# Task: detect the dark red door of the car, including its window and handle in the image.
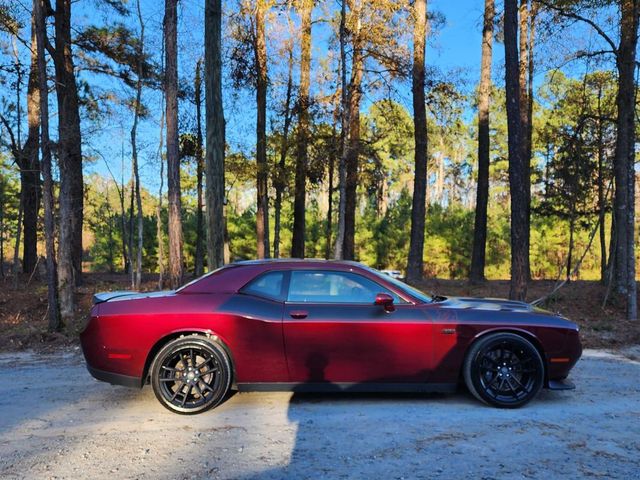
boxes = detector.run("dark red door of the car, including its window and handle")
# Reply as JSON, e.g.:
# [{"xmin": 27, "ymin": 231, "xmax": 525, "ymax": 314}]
[{"xmin": 283, "ymin": 270, "xmax": 432, "ymax": 383}]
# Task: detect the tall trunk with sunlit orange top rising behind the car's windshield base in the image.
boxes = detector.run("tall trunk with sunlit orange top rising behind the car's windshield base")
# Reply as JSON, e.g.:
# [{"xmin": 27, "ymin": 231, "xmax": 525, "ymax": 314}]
[{"xmin": 407, "ymin": 0, "xmax": 427, "ymax": 282}]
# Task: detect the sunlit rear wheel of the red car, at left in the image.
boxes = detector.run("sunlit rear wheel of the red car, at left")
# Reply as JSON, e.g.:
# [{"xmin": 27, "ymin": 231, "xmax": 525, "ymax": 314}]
[{"xmin": 151, "ymin": 335, "xmax": 232, "ymax": 415}]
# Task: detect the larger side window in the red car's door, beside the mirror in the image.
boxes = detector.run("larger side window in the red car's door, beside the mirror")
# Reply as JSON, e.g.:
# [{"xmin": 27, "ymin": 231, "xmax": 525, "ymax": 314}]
[{"xmin": 287, "ymin": 271, "xmax": 405, "ymax": 304}]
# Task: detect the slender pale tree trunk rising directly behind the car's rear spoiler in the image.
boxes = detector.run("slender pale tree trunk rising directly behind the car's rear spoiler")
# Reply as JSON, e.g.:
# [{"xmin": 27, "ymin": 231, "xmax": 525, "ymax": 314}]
[{"xmin": 131, "ymin": 0, "xmax": 144, "ymax": 290}]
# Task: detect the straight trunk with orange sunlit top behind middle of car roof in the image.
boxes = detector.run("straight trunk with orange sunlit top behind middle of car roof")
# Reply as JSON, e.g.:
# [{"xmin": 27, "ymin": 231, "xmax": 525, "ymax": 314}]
[{"xmin": 291, "ymin": 0, "xmax": 313, "ymax": 258}]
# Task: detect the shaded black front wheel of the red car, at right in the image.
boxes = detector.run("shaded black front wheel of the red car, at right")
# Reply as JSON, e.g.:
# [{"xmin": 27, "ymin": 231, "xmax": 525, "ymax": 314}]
[{"xmin": 463, "ymin": 333, "xmax": 544, "ymax": 408}]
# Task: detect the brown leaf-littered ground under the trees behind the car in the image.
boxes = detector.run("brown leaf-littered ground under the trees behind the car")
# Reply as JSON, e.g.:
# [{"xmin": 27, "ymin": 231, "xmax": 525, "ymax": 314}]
[{"xmin": 0, "ymin": 273, "xmax": 640, "ymax": 352}]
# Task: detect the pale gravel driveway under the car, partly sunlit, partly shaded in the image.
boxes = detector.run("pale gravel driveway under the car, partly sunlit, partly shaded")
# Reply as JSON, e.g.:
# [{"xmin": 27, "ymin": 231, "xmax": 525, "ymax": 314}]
[{"xmin": 0, "ymin": 350, "xmax": 640, "ymax": 480}]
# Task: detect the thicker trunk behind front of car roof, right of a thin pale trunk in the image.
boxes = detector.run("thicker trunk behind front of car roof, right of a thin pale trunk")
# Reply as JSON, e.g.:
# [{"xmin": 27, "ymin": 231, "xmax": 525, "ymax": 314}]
[{"xmin": 342, "ymin": 0, "xmax": 364, "ymax": 260}]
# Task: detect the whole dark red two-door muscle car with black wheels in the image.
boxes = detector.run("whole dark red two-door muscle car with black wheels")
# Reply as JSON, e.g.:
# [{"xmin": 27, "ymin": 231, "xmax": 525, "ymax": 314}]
[{"xmin": 81, "ymin": 260, "xmax": 582, "ymax": 413}]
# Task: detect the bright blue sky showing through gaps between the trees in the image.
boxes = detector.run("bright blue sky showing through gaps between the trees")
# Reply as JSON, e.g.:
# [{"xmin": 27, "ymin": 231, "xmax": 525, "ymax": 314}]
[{"xmin": 74, "ymin": 0, "xmax": 604, "ymax": 193}]
